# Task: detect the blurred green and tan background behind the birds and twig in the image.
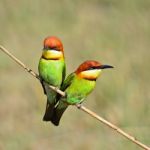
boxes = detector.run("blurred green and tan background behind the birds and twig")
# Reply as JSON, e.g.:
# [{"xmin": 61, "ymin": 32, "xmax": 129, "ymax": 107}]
[{"xmin": 0, "ymin": 0, "xmax": 150, "ymax": 150}]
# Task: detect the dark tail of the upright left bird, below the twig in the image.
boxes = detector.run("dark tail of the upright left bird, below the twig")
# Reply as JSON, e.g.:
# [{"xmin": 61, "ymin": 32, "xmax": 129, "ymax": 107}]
[{"xmin": 43, "ymin": 100, "xmax": 55, "ymax": 121}]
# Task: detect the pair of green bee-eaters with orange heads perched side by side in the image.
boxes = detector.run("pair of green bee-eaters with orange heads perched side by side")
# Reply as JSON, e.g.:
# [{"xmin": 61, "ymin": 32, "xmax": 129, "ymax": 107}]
[{"xmin": 38, "ymin": 36, "xmax": 113, "ymax": 126}]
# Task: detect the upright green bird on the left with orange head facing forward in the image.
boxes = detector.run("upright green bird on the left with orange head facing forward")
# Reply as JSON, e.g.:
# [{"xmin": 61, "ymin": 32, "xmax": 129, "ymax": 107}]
[{"xmin": 38, "ymin": 36, "xmax": 66, "ymax": 121}]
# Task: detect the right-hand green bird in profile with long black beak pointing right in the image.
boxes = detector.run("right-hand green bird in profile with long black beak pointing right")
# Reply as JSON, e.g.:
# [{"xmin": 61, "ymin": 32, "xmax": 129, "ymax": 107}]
[{"xmin": 51, "ymin": 60, "xmax": 113, "ymax": 126}]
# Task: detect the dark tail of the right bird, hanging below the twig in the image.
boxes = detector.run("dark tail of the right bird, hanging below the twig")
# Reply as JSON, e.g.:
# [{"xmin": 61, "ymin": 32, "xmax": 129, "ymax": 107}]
[{"xmin": 51, "ymin": 100, "xmax": 68, "ymax": 126}]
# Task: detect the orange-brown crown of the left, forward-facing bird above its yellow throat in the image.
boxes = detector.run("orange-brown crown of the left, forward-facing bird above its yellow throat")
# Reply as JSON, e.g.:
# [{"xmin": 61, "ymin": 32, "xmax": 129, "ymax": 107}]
[{"xmin": 44, "ymin": 36, "xmax": 63, "ymax": 52}]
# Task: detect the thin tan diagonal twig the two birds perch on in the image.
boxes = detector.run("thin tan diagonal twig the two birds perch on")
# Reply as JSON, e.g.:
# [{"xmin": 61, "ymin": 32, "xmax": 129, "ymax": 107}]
[{"xmin": 0, "ymin": 45, "xmax": 150, "ymax": 150}]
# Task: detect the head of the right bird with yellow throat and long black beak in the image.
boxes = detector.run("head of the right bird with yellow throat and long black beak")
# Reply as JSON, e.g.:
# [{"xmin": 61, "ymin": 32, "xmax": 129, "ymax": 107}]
[{"xmin": 75, "ymin": 60, "xmax": 113, "ymax": 80}]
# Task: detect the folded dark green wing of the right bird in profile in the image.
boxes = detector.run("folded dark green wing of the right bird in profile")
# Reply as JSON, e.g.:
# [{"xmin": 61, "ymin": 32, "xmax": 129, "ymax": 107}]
[{"xmin": 60, "ymin": 73, "xmax": 75, "ymax": 91}]
